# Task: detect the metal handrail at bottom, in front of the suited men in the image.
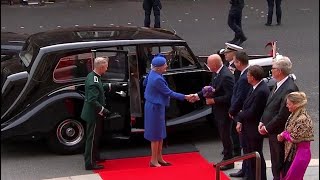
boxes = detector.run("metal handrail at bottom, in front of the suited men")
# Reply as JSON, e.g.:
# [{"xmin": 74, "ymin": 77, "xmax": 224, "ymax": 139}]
[{"xmin": 214, "ymin": 151, "xmax": 261, "ymax": 180}]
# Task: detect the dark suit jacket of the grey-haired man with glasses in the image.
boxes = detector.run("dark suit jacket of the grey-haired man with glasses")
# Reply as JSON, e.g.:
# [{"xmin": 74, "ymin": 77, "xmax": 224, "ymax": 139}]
[{"xmin": 260, "ymin": 77, "xmax": 299, "ymax": 134}]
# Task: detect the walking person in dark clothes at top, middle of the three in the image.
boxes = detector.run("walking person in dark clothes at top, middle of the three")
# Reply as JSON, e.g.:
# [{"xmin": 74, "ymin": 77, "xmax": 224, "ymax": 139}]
[{"xmin": 228, "ymin": 0, "xmax": 247, "ymax": 45}]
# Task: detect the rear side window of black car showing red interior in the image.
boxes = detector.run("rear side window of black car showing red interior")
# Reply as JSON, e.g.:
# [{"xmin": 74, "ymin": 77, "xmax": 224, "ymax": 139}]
[{"xmin": 53, "ymin": 52, "xmax": 93, "ymax": 82}]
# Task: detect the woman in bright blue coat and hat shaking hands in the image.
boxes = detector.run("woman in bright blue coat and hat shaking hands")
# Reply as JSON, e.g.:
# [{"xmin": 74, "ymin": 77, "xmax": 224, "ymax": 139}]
[{"xmin": 144, "ymin": 54, "xmax": 190, "ymax": 167}]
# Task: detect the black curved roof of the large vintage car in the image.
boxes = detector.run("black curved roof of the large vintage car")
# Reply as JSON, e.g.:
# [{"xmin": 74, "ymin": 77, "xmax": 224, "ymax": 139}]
[{"xmin": 29, "ymin": 26, "xmax": 182, "ymax": 48}]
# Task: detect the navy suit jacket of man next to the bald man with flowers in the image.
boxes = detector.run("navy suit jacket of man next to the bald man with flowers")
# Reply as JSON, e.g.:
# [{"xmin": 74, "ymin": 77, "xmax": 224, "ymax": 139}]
[{"xmin": 229, "ymin": 69, "xmax": 251, "ymax": 116}]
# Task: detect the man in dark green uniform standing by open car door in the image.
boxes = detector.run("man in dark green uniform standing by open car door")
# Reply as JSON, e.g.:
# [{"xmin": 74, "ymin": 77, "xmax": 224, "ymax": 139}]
[{"xmin": 81, "ymin": 57, "xmax": 117, "ymax": 170}]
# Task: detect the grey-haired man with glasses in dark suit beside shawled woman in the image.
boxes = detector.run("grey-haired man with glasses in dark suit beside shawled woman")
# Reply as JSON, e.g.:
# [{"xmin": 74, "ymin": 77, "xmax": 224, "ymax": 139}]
[{"xmin": 258, "ymin": 56, "xmax": 299, "ymax": 180}]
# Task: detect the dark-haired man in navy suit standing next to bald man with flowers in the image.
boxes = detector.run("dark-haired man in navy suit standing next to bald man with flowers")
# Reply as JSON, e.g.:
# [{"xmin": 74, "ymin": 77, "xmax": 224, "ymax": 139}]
[{"xmin": 229, "ymin": 51, "xmax": 251, "ymax": 177}]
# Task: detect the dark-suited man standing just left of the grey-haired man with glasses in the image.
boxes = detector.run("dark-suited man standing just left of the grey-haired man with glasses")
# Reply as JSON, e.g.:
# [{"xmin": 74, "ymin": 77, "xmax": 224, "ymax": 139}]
[{"xmin": 235, "ymin": 65, "xmax": 270, "ymax": 180}]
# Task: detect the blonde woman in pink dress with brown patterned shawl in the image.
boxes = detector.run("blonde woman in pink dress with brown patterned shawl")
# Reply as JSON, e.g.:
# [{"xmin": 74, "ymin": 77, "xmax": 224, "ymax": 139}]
[{"xmin": 278, "ymin": 92, "xmax": 314, "ymax": 180}]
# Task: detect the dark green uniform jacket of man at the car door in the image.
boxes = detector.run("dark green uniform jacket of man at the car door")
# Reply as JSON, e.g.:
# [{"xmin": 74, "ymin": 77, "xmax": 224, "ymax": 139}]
[{"xmin": 81, "ymin": 71, "xmax": 109, "ymax": 122}]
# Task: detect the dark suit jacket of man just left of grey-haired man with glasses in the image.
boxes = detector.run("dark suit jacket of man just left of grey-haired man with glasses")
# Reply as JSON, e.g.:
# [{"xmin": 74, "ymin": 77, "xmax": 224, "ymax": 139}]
[{"xmin": 236, "ymin": 81, "xmax": 270, "ymax": 138}]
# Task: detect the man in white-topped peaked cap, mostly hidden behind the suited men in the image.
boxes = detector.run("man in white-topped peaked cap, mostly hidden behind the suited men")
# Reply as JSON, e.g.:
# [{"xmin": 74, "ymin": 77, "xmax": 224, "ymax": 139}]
[{"xmin": 223, "ymin": 43, "xmax": 243, "ymax": 156}]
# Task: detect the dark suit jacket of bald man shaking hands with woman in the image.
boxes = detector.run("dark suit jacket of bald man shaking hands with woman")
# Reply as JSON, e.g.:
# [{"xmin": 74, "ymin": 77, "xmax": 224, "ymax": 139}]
[{"xmin": 198, "ymin": 66, "xmax": 234, "ymax": 108}]
